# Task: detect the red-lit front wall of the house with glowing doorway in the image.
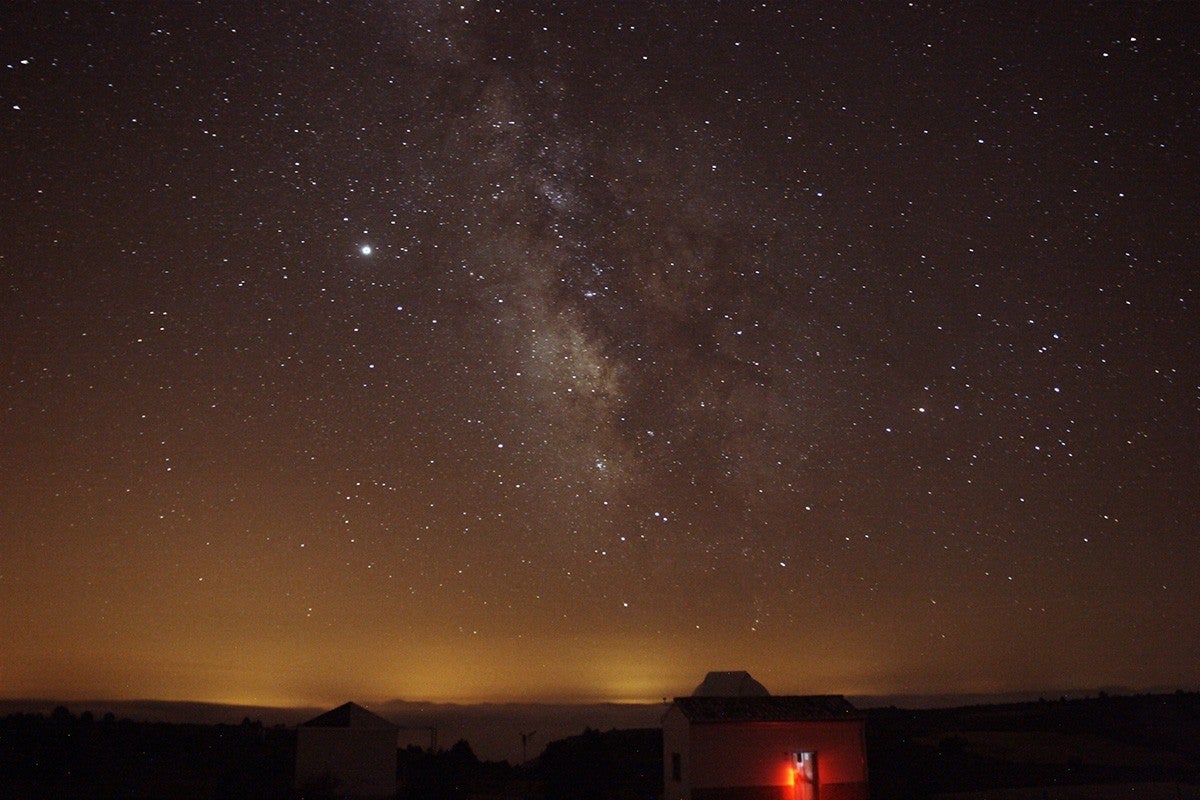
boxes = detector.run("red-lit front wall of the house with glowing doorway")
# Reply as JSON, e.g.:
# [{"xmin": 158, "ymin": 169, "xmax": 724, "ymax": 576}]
[{"xmin": 664, "ymin": 715, "xmax": 866, "ymax": 800}]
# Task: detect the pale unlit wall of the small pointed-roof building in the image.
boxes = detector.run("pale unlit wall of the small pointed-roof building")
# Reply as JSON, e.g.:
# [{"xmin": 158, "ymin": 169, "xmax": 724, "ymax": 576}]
[{"xmin": 295, "ymin": 726, "xmax": 396, "ymax": 798}]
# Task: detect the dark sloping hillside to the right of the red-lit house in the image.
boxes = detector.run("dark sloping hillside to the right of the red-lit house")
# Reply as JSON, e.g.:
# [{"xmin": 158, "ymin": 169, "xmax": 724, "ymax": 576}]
[{"xmin": 866, "ymin": 692, "xmax": 1200, "ymax": 800}]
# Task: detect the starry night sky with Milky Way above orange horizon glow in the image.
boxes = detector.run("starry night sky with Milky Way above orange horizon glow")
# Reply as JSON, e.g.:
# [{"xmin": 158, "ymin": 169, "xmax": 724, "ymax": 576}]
[{"xmin": 0, "ymin": 0, "xmax": 1200, "ymax": 704}]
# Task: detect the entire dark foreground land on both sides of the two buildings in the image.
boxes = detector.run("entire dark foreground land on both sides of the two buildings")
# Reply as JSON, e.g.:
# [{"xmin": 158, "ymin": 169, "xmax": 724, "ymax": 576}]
[{"xmin": 0, "ymin": 692, "xmax": 1200, "ymax": 800}]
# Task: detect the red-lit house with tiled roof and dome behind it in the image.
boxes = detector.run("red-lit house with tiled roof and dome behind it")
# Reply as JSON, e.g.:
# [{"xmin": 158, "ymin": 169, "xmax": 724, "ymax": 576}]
[{"xmin": 662, "ymin": 672, "xmax": 866, "ymax": 800}]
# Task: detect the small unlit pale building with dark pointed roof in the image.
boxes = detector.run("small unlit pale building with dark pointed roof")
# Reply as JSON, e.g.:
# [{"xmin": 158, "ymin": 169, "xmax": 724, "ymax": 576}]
[{"xmin": 295, "ymin": 703, "xmax": 400, "ymax": 799}]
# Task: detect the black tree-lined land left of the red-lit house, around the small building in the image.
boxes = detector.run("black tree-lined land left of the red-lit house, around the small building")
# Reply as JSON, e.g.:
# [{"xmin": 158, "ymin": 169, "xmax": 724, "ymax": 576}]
[{"xmin": 0, "ymin": 708, "xmax": 662, "ymax": 800}]
